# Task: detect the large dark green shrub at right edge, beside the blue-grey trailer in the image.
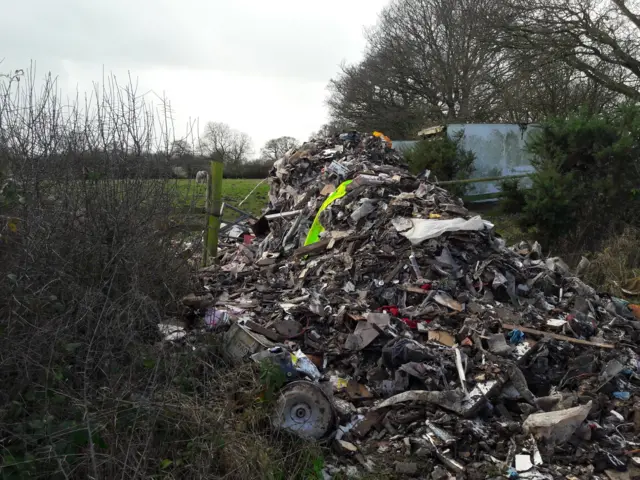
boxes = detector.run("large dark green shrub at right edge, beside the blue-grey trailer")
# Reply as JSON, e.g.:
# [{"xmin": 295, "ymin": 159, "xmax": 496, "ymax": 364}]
[{"xmin": 509, "ymin": 106, "xmax": 640, "ymax": 251}]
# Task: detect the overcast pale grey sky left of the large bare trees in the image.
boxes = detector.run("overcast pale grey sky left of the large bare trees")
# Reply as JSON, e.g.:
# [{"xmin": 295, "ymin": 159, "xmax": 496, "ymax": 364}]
[{"xmin": 0, "ymin": 0, "xmax": 388, "ymax": 155}]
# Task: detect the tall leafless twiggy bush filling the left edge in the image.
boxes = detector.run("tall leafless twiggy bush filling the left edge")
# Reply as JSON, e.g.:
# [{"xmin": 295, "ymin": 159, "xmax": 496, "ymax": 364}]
[{"xmin": 0, "ymin": 64, "xmax": 197, "ymax": 478}]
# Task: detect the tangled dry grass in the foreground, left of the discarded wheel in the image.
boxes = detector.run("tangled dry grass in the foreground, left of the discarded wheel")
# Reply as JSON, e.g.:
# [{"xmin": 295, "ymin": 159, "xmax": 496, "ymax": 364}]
[{"xmin": 100, "ymin": 337, "xmax": 330, "ymax": 480}]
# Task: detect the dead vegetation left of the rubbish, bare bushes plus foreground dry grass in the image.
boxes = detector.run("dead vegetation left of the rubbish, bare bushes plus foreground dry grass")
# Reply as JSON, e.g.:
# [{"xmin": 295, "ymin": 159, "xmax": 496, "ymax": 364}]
[{"xmin": 0, "ymin": 66, "xmax": 321, "ymax": 479}]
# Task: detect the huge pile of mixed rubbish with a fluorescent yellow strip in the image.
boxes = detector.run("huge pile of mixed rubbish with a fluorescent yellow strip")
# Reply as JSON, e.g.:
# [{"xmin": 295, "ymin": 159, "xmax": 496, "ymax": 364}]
[{"xmin": 175, "ymin": 133, "xmax": 640, "ymax": 480}]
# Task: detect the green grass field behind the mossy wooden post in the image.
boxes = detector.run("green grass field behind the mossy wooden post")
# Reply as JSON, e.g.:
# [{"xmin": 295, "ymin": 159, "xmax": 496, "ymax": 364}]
[{"xmin": 178, "ymin": 178, "xmax": 269, "ymax": 219}]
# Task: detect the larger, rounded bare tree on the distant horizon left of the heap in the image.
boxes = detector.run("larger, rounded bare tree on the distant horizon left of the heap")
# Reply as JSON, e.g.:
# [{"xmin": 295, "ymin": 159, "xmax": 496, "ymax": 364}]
[{"xmin": 200, "ymin": 122, "xmax": 252, "ymax": 165}]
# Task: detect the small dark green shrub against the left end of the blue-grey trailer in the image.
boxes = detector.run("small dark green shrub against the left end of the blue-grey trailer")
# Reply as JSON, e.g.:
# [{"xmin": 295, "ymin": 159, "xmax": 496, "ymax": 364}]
[{"xmin": 405, "ymin": 132, "xmax": 475, "ymax": 196}]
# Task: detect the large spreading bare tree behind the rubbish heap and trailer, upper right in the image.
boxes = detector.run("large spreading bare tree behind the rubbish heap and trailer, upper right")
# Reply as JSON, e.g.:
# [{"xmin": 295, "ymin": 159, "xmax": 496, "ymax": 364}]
[{"xmin": 327, "ymin": 0, "xmax": 616, "ymax": 131}]
